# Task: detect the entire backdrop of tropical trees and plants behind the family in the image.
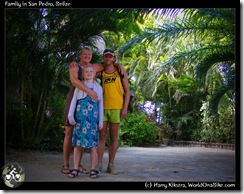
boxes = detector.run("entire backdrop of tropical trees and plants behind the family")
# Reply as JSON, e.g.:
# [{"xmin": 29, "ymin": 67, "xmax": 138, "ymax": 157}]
[{"xmin": 4, "ymin": 8, "xmax": 239, "ymax": 151}]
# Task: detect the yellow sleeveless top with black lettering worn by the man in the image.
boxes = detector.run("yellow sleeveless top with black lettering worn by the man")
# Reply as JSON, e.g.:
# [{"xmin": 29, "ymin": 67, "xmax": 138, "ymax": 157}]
[{"xmin": 102, "ymin": 70, "xmax": 124, "ymax": 109}]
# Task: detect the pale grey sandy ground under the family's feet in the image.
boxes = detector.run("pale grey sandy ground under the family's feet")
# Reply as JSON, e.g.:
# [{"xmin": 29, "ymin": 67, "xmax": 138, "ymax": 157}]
[{"xmin": 2, "ymin": 145, "xmax": 237, "ymax": 190}]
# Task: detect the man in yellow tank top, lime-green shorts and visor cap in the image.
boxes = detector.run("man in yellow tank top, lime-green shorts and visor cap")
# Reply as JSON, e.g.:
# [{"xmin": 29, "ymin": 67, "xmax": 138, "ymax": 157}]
[{"xmin": 97, "ymin": 49, "xmax": 130, "ymax": 174}]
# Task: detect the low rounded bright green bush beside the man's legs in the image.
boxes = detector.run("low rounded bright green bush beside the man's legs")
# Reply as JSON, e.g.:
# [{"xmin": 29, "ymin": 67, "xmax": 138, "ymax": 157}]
[{"xmin": 119, "ymin": 112, "xmax": 159, "ymax": 146}]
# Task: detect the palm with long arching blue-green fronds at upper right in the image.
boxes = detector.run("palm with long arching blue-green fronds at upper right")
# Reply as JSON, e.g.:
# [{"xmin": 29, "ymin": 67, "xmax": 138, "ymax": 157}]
[{"xmin": 120, "ymin": 8, "xmax": 236, "ymax": 121}]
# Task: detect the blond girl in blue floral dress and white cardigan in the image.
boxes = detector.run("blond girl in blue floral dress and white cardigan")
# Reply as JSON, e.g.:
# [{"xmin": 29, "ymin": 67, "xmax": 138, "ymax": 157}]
[{"xmin": 68, "ymin": 65, "xmax": 103, "ymax": 178}]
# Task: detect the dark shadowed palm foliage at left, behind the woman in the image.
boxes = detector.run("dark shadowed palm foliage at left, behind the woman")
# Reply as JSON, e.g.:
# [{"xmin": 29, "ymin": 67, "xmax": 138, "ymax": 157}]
[{"xmin": 5, "ymin": 8, "xmax": 152, "ymax": 147}]
